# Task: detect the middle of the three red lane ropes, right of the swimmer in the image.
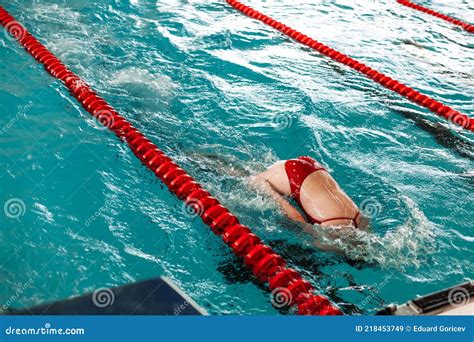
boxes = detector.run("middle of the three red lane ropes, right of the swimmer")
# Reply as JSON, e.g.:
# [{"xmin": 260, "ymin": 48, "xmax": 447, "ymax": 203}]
[{"xmin": 226, "ymin": 0, "xmax": 474, "ymax": 131}]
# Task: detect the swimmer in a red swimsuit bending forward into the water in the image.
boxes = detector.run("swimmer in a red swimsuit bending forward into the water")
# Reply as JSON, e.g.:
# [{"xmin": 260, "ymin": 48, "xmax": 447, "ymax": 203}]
[{"xmin": 251, "ymin": 157, "xmax": 368, "ymax": 229}]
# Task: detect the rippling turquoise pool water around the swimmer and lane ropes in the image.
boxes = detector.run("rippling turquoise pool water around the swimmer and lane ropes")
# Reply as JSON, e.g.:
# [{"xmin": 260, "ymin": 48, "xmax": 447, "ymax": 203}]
[{"xmin": 0, "ymin": 0, "xmax": 474, "ymax": 314}]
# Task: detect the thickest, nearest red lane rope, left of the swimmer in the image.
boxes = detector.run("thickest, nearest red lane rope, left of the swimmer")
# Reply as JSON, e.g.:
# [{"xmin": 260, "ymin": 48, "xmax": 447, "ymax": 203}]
[{"xmin": 0, "ymin": 6, "xmax": 342, "ymax": 315}]
